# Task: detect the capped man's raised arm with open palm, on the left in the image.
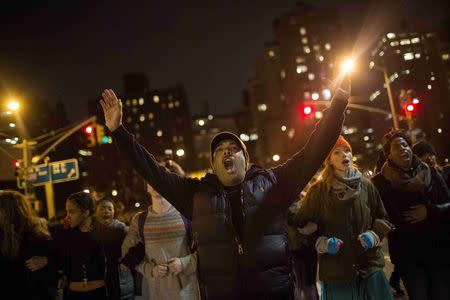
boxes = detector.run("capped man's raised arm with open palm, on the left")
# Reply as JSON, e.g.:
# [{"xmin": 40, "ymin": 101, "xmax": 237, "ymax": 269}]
[{"xmin": 101, "ymin": 90, "xmax": 198, "ymax": 219}]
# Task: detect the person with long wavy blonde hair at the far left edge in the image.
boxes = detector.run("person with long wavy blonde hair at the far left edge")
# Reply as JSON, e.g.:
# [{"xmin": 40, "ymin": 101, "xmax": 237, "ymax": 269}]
[{"xmin": 0, "ymin": 190, "xmax": 52, "ymax": 300}]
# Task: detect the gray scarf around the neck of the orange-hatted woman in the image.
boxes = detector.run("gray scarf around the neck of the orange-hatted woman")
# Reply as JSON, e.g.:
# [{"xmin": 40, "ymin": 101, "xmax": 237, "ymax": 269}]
[{"xmin": 331, "ymin": 168, "xmax": 362, "ymax": 200}]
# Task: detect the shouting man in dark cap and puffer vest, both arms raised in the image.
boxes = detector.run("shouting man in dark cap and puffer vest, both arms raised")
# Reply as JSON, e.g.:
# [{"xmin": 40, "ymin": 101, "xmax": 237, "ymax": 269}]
[{"xmin": 100, "ymin": 85, "xmax": 348, "ymax": 299}]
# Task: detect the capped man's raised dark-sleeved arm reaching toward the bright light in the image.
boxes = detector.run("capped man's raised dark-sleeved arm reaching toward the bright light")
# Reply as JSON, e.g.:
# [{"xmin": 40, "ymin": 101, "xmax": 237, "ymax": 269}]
[{"xmin": 273, "ymin": 98, "xmax": 348, "ymax": 210}]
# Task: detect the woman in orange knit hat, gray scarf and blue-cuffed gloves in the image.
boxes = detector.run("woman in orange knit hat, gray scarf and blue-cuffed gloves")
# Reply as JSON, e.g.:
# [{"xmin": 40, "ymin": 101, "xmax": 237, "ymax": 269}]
[{"xmin": 295, "ymin": 136, "xmax": 392, "ymax": 300}]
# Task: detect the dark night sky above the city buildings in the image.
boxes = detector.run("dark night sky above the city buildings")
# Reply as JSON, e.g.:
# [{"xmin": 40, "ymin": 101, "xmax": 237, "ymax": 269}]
[{"xmin": 0, "ymin": 0, "xmax": 448, "ymax": 121}]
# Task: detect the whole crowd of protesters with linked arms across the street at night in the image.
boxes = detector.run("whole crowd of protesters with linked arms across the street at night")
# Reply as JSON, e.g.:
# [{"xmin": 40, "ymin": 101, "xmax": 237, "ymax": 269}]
[{"xmin": 0, "ymin": 84, "xmax": 450, "ymax": 300}]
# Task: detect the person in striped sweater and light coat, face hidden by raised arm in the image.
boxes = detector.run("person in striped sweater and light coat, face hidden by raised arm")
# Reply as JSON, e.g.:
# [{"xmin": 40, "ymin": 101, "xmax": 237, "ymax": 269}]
[{"xmin": 122, "ymin": 163, "xmax": 200, "ymax": 300}]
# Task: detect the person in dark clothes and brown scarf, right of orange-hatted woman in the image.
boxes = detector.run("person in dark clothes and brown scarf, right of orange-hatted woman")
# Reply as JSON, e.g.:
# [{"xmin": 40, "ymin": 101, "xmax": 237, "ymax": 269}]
[{"xmin": 373, "ymin": 130, "xmax": 450, "ymax": 299}]
